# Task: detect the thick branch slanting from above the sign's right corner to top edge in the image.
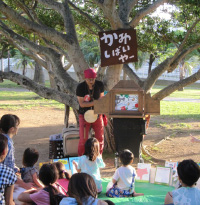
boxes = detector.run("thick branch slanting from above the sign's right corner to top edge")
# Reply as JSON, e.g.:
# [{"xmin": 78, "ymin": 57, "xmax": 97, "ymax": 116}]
[{"xmin": 129, "ymin": 0, "xmax": 169, "ymax": 28}]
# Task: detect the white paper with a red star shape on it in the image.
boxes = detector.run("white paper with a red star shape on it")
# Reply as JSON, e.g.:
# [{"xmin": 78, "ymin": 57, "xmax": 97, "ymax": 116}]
[{"xmin": 136, "ymin": 163, "xmax": 151, "ymax": 182}]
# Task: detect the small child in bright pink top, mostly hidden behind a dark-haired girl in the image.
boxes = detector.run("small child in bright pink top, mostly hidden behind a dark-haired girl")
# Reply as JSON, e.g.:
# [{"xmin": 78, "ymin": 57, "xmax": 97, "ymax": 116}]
[{"xmin": 54, "ymin": 161, "xmax": 71, "ymax": 192}]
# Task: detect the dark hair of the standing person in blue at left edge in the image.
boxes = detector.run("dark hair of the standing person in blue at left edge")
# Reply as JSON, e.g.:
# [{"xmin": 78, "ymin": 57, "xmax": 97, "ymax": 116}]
[{"xmin": 0, "ymin": 114, "xmax": 20, "ymax": 134}]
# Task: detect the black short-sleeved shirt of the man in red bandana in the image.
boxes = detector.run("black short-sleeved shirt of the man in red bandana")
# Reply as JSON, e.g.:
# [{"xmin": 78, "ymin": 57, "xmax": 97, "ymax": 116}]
[{"xmin": 76, "ymin": 80, "xmax": 104, "ymax": 114}]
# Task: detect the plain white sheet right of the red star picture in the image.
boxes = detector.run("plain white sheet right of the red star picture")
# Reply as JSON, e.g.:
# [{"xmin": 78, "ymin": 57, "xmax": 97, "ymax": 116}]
[{"xmin": 155, "ymin": 167, "xmax": 171, "ymax": 185}]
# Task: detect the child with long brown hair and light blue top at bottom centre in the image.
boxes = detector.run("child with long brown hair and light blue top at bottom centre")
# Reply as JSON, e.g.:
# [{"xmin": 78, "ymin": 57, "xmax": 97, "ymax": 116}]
[{"xmin": 60, "ymin": 173, "xmax": 107, "ymax": 205}]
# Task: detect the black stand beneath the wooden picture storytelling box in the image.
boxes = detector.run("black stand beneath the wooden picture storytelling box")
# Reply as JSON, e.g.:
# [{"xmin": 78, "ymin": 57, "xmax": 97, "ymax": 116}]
[{"xmin": 113, "ymin": 118, "xmax": 146, "ymax": 158}]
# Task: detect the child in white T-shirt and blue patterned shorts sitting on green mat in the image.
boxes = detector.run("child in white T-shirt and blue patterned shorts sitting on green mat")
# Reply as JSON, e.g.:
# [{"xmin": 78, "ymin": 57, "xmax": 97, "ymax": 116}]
[{"xmin": 106, "ymin": 149, "xmax": 144, "ymax": 197}]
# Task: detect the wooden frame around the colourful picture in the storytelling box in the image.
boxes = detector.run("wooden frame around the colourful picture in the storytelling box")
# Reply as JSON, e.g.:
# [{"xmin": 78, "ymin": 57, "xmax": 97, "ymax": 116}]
[{"xmin": 110, "ymin": 90, "xmax": 144, "ymax": 118}]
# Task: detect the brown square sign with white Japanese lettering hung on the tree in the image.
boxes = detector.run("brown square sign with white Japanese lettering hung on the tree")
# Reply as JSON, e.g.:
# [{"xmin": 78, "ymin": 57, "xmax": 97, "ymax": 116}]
[{"xmin": 99, "ymin": 29, "xmax": 138, "ymax": 67}]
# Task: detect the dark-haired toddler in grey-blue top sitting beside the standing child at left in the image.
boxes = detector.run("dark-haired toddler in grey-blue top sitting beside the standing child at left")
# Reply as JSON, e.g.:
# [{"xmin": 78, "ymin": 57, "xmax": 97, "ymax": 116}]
[{"xmin": 20, "ymin": 148, "xmax": 44, "ymax": 187}]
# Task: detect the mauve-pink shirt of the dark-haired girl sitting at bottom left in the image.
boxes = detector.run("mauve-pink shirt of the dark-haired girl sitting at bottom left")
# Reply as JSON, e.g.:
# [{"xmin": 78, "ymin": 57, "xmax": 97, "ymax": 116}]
[{"xmin": 30, "ymin": 189, "xmax": 50, "ymax": 205}]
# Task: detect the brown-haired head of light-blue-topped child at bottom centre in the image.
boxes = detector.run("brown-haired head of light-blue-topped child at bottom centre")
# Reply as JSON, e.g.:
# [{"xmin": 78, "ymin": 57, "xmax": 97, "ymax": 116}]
[{"xmin": 68, "ymin": 173, "xmax": 97, "ymax": 204}]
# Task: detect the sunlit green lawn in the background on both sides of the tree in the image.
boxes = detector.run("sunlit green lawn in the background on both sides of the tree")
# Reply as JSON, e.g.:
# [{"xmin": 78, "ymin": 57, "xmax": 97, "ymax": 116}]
[{"xmin": 0, "ymin": 80, "xmax": 200, "ymax": 118}]
